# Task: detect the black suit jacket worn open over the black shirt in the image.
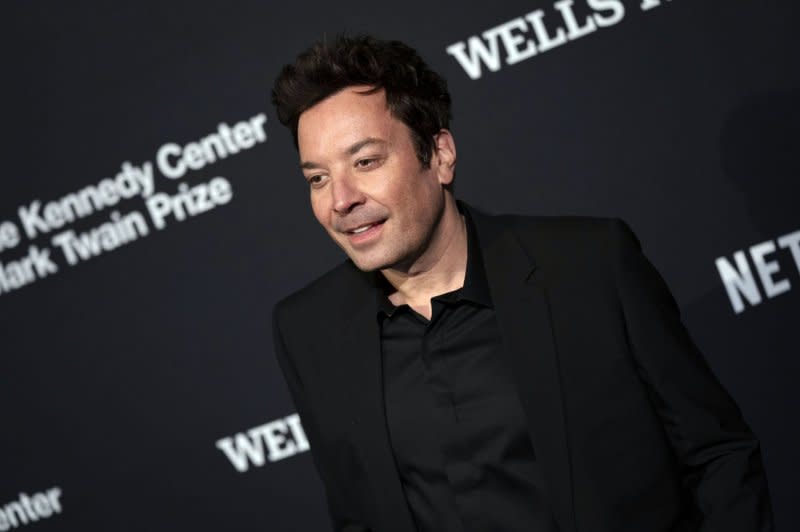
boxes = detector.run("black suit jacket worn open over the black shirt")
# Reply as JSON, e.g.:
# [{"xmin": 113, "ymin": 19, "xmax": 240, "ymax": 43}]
[{"xmin": 273, "ymin": 204, "xmax": 772, "ymax": 532}]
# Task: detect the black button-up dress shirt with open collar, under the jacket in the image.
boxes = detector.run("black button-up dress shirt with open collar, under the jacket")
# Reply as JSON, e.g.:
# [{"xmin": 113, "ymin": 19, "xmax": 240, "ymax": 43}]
[{"xmin": 376, "ymin": 211, "xmax": 558, "ymax": 532}]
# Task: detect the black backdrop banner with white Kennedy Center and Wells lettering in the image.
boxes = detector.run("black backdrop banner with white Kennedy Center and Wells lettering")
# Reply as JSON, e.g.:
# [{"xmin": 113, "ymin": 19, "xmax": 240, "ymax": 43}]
[{"xmin": 0, "ymin": 0, "xmax": 800, "ymax": 532}]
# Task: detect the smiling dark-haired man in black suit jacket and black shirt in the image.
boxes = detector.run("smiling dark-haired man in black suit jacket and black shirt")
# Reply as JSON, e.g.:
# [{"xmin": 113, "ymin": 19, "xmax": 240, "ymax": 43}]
[{"xmin": 273, "ymin": 37, "xmax": 772, "ymax": 532}]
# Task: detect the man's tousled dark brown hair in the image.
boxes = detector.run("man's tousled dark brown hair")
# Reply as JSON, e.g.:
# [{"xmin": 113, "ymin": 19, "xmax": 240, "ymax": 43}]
[{"xmin": 272, "ymin": 35, "xmax": 452, "ymax": 167}]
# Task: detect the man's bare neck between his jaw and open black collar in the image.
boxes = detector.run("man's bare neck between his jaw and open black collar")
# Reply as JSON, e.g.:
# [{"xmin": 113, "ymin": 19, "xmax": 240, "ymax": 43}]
[{"xmin": 381, "ymin": 199, "xmax": 467, "ymax": 318}]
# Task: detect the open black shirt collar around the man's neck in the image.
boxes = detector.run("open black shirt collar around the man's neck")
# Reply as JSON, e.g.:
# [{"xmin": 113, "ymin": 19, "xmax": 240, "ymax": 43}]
[{"xmin": 372, "ymin": 205, "xmax": 492, "ymax": 316}]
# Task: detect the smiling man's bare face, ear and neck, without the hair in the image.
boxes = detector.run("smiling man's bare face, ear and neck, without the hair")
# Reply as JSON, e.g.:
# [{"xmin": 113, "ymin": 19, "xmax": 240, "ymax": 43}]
[{"xmin": 297, "ymin": 86, "xmax": 466, "ymax": 319}]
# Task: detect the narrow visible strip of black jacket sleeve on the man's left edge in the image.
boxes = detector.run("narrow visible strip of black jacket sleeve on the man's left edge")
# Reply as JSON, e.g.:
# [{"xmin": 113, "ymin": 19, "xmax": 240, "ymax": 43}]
[{"xmin": 272, "ymin": 303, "xmax": 370, "ymax": 532}]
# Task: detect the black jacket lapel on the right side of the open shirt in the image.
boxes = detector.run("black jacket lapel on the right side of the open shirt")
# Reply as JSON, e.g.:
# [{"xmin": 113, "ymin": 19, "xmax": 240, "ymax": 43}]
[{"xmin": 465, "ymin": 206, "xmax": 576, "ymax": 532}]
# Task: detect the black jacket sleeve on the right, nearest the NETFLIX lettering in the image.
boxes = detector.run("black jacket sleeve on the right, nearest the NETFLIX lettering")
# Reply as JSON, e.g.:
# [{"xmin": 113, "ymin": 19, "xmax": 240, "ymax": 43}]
[{"xmin": 609, "ymin": 219, "xmax": 773, "ymax": 532}]
